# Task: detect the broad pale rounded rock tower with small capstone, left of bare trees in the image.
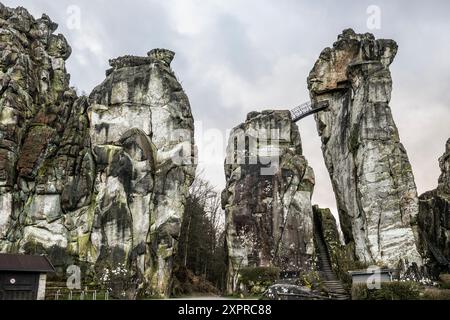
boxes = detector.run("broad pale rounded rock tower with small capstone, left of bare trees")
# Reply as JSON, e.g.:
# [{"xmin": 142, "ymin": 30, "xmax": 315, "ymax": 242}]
[{"xmin": 87, "ymin": 50, "xmax": 195, "ymax": 294}]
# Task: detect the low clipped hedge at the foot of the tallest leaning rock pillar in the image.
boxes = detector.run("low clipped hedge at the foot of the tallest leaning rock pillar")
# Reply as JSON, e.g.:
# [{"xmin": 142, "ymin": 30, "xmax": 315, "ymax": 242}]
[{"xmin": 352, "ymin": 281, "xmax": 421, "ymax": 300}]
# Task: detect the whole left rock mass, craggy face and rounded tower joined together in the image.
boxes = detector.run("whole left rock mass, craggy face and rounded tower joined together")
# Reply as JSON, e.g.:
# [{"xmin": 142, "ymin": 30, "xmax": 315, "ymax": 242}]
[{"xmin": 0, "ymin": 6, "xmax": 195, "ymax": 295}]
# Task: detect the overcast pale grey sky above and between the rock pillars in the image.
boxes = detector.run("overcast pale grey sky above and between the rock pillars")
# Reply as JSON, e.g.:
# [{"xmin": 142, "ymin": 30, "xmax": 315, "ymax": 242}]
[{"xmin": 3, "ymin": 0, "xmax": 450, "ymax": 219}]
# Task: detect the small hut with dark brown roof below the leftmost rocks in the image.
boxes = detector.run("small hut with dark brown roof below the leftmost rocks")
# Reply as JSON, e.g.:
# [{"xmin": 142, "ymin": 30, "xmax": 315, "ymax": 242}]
[{"xmin": 0, "ymin": 253, "xmax": 55, "ymax": 300}]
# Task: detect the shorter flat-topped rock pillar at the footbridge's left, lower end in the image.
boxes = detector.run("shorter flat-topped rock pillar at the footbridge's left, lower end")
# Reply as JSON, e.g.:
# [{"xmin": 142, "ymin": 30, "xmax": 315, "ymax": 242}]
[{"xmin": 222, "ymin": 111, "xmax": 314, "ymax": 292}]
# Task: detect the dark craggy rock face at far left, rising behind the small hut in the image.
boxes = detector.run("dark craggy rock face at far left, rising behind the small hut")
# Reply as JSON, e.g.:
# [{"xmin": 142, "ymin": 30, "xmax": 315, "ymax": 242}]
[{"xmin": 0, "ymin": 5, "xmax": 77, "ymax": 258}]
